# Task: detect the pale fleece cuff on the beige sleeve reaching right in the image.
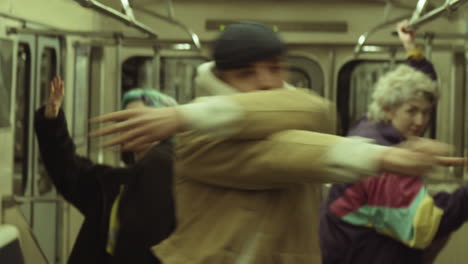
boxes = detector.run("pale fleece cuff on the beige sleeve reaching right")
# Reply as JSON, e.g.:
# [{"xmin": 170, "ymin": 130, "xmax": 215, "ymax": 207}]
[{"xmin": 326, "ymin": 137, "xmax": 387, "ymax": 182}]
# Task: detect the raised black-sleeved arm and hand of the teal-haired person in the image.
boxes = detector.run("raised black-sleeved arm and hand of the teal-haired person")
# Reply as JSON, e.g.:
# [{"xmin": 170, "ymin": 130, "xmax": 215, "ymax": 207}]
[{"xmin": 34, "ymin": 78, "xmax": 116, "ymax": 214}]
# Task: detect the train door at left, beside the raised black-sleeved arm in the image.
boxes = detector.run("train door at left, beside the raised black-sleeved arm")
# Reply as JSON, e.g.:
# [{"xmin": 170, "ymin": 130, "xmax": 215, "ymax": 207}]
[{"xmin": 14, "ymin": 35, "xmax": 61, "ymax": 263}]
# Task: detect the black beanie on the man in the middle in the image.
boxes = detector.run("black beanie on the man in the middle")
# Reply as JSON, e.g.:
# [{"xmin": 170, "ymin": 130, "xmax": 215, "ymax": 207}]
[{"xmin": 213, "ymin": 22, "xmax": 286, "ymax": 70}]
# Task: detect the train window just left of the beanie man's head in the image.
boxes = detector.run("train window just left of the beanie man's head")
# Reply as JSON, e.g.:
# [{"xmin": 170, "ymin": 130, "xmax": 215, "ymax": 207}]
[{"xmin": 160, "ymin": 57, "xmax": 207, "ymax": 104}]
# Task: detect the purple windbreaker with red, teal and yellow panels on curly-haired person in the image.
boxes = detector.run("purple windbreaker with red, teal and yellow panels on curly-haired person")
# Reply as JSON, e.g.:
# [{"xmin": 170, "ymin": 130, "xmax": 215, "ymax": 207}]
[{"xmin": 320, "ymin": 117, "xmax": 443, "ymax": 264}]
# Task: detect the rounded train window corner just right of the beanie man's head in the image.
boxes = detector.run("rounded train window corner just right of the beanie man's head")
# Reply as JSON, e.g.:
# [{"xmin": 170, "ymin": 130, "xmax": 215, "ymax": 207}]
[{"xmin": 287, "ymin": 56, "xmax": 325, "ymax": 95}]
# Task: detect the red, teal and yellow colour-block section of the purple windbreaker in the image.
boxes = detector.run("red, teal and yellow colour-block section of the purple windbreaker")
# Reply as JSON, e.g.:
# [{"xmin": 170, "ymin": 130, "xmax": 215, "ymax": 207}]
[{"xmin": 329, "ymin": 170, "xmax": 443, "ymax": 249}]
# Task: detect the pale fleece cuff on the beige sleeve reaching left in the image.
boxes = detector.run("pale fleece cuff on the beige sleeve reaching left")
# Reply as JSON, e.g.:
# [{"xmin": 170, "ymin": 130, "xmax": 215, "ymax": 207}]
[{"xmin": 177, "ymin": 97, "xmax": 244, "ymax": 137}]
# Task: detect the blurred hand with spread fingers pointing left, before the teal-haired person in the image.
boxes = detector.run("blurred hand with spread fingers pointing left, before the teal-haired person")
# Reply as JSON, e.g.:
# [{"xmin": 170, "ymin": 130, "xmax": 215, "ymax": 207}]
[{"xmin": 91, "ymin": 107, "xmax": 183, "ymax": 151}]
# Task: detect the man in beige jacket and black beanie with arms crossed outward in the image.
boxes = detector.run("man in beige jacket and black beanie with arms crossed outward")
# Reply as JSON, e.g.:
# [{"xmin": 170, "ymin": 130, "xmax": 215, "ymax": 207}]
[{"xmin": 95, "ymin": 23, "xmax": 454, "ymax": 264}]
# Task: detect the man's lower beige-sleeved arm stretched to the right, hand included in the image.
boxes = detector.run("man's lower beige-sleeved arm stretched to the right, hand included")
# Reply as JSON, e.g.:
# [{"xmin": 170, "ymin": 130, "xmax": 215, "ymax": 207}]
[{"xmin": 176, "ymin": 130, "xmax": 460, "ymax": 189}]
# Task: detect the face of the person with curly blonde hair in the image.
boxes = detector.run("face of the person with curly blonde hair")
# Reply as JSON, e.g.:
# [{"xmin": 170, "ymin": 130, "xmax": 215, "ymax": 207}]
[{"xmin": 386, "ymin": 98, "xmax": 434, "ymax": 138}]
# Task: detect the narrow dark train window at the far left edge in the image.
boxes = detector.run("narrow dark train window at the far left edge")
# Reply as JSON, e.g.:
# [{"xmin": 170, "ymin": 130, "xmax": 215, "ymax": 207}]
[{"xmin": 0, "ymin": 40, "xmax": 13, "ymax": 127}]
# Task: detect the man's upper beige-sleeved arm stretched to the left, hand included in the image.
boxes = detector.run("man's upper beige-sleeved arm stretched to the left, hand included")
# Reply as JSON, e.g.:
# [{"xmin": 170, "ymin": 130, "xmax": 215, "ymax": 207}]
[{"xmin": 89, "ymin": 89, "xmax": 336, "ymax": 150}]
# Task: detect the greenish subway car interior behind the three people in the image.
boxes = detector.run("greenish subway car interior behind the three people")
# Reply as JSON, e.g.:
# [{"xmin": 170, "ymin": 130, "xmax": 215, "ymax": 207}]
[{"xmin": 0, "ymin": 0, "xmax": 468, "ymax": 264}]
